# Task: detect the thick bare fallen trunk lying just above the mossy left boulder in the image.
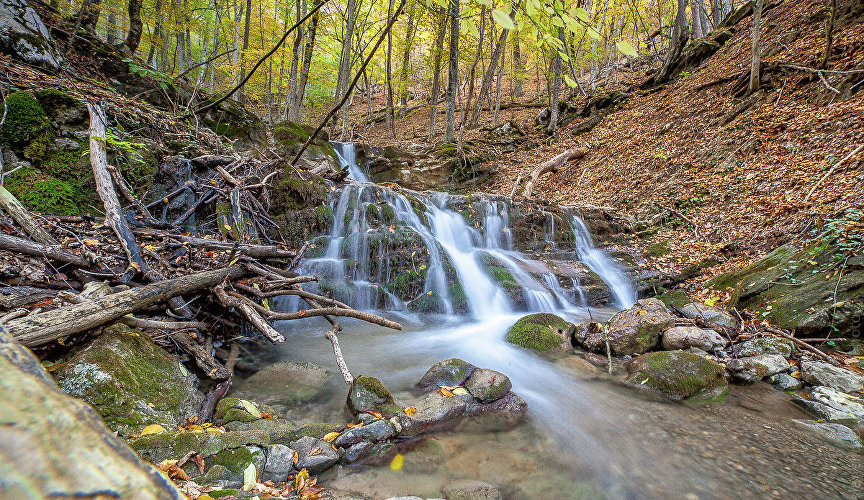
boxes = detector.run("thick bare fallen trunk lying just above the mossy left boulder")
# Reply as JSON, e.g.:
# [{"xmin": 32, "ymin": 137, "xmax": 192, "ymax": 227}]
[{"xmin": 6, "ymin": 267, "xmax": 243, "ymax": 347}]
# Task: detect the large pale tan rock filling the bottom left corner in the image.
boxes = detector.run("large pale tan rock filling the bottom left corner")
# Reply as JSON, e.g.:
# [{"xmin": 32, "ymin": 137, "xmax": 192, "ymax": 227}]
[{"xmin": 0, "ymin": 329, "xmax": 184, "ymax": 500}]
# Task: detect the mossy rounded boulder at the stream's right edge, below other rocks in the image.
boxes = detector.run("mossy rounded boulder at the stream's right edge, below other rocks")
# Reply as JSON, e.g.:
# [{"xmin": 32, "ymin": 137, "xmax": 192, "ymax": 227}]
[{"xmin": 624, "ymin": 351, "xmax": 729, "ymax": 401}]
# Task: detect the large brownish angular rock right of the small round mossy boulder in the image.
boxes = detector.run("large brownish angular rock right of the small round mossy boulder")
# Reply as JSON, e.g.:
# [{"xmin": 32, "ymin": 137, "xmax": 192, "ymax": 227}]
[{"xmin": 584, "ymin": 299, "xmax": 675, "ymax": 356}]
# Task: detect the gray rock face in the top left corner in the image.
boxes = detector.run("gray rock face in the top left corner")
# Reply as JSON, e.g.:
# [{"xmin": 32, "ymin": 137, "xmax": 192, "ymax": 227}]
[{"xmin": 0, "ymin": 0, "xmax": 62, "ymax": 72}]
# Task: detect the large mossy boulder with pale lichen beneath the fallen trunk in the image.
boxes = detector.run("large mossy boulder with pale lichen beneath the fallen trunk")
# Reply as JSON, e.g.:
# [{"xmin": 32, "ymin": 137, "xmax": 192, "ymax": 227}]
[{"xmin": 56, "ymin": 326, "xmax": 203, "ymax": 436}]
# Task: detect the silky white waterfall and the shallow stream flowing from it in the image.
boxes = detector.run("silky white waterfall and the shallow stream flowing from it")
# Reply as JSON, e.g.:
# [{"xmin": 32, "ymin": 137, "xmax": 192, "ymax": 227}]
[{"xmin": 258, "ymin": 143, "xmax": 864, "ymax": 499}]
